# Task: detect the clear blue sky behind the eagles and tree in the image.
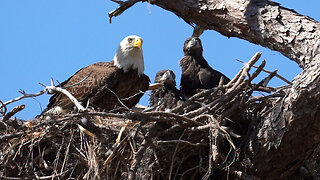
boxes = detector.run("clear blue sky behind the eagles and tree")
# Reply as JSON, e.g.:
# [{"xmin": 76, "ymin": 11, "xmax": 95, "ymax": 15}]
[{"xmin": 0, "ymin": 0, "xmax": 320, "ymax": 120}]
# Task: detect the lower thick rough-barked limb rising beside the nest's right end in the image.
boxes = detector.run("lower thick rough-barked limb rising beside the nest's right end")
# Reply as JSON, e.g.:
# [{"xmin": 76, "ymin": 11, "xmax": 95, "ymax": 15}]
[{"xmin": 246, "ymin": 69, "xmax": 320, "ymax": 178}]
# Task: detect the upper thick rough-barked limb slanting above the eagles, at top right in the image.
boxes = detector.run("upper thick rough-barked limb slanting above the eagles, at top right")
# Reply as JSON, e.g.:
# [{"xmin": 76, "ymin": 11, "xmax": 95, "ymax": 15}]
[{"xmin": 109, "ymin": 0, "xmax": 320, "ymax": 67}]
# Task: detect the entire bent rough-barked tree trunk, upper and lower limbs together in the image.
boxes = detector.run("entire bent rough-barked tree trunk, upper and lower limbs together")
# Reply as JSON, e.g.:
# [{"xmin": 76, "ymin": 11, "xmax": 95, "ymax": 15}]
[{"xmin": 111, "ymin": 0, "xmax": 320, "ymax": 179}]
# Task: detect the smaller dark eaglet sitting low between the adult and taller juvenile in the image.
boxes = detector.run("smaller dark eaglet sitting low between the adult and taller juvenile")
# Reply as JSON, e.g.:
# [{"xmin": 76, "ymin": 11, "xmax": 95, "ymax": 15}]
[{"xmin": 149, "ymin": 69, "xmax": 182, "ymax": 111}]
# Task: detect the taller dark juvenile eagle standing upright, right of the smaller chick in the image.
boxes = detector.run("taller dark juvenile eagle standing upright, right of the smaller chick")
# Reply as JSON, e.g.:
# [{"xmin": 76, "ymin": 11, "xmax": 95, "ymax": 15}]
[{"xmin": 179, "ymin": 37, "xmax": 230, "ymax": 99}]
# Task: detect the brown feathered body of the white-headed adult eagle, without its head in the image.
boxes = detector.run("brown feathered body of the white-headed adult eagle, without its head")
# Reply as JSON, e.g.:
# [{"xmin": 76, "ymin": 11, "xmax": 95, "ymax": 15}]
[{"xmin": 43, "ymin": 62, "xmax": 150, "ymax": 111}]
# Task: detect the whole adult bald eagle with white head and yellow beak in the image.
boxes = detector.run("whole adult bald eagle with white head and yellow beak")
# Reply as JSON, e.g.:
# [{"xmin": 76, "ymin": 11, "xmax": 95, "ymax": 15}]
[{"xmin": 42, "ymin": 35, "xmax": 150, "ymax": 114}]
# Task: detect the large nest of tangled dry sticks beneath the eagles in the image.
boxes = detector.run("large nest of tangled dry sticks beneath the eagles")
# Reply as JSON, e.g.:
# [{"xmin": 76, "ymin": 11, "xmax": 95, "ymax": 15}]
[{"xmin": 0, "ymin": 53, "xmax": 298, "ymax": 179}]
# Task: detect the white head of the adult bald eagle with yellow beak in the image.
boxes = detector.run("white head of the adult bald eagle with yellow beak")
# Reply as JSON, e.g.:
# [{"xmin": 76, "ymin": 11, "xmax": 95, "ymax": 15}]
[{"xmin": 113, "ymin": 35, "xmax": 144, "ymax": 76}]
